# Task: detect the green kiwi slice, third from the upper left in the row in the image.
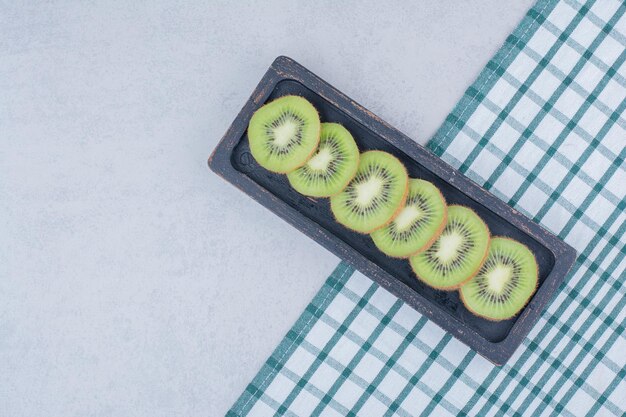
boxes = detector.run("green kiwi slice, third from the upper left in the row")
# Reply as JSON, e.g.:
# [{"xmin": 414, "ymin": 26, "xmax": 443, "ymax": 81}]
[{"xmin": 330, "ymin": 151, "xmax": 409, "ymax": 233}]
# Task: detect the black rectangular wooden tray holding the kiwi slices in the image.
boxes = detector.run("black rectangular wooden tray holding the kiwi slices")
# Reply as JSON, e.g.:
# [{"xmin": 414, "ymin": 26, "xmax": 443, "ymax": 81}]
[{"xmin": 209, "ymin": 57, "xmax": 576, "ymax": 365}]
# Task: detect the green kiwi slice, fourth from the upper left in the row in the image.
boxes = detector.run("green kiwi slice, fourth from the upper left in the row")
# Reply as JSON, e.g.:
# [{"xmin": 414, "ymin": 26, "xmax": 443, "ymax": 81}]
[{"xmin": 371, "ymin": 179, "xmax": 448, "ymax": 258}]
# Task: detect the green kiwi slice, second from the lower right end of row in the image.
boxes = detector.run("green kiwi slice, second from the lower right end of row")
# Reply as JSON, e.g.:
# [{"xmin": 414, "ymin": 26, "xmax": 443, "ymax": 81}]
[{"xmin": 410, "ymin": 205, "xmax": 489, "ymax": 290}]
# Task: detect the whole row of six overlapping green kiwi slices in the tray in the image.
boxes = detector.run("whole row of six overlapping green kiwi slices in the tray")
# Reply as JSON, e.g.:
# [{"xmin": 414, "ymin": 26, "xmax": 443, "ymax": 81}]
[{"xmin": 248, "ymin": 96, "xmax": 538, "ymax": 321}]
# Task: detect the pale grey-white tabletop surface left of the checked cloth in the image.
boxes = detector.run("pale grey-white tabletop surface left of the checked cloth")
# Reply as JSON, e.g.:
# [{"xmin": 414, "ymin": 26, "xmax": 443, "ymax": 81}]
[{"xmin": 0, "ymin": 0, "xmax": 531, "ymax": 417}]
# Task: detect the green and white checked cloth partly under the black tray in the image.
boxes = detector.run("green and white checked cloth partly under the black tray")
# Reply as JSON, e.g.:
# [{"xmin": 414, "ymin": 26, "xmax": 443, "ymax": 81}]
[{"xmin": 228, "ymin": 0, "xmax": 626, "ymax": 416}]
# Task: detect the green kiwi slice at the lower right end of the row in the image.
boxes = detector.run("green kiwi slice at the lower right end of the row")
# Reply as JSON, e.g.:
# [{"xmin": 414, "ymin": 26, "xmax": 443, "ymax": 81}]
[{"xmin": 459, "ymin": 237, "xmax": 538, "ymax": 321}]
